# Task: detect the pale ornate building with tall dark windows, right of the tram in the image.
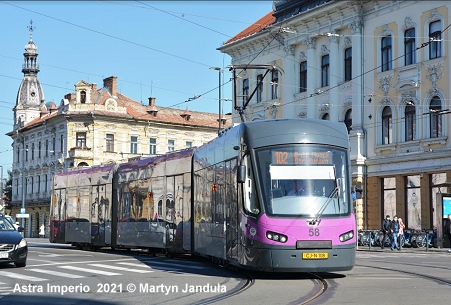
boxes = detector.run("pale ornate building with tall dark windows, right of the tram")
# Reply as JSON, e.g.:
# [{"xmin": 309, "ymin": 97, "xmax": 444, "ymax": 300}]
[{"xmin": 218, "ymin": 0, "xmax": 451, "ymax": 229}]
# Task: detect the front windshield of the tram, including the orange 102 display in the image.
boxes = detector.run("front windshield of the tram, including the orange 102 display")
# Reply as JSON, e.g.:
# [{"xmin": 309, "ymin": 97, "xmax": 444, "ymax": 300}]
[{"xmin": 257, "ymin": 144, "xmax": 350, "ymax": 217}]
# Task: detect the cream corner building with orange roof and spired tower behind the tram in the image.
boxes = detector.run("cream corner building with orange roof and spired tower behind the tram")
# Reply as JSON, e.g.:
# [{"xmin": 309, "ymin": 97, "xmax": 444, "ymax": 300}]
[{"xmin": 7, "ymin": 28, "xmax": 231, "ymax": 236}]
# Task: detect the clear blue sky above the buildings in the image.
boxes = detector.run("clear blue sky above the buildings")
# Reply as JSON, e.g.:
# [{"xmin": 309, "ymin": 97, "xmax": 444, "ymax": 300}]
[{"xmin": 0, "ymin": 1, "xmax": 272, "ymax": 173}]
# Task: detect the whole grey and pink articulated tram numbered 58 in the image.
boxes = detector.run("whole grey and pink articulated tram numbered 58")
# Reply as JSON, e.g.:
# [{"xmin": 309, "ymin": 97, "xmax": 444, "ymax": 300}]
[{"xmin": 51, "ymin": 119, "xmax": 356, "ymax": 272}]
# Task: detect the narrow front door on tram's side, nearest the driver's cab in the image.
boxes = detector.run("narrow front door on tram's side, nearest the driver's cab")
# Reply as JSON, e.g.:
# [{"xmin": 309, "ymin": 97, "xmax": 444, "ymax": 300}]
[{"xmin": 224, "ymin": 160, "xmax": 238, "ymax": 260}]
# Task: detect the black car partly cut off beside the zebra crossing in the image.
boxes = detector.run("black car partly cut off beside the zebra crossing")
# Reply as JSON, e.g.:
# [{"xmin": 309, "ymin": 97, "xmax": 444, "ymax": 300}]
[{"xmin": 0, "ymin": 215, "xmax": 28, "ymax": 267}]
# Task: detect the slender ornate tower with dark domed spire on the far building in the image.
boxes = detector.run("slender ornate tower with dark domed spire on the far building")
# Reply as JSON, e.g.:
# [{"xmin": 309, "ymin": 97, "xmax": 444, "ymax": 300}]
[{"xmin": 13, "ymin": 21, "xmax": 45, "ymax": 130}]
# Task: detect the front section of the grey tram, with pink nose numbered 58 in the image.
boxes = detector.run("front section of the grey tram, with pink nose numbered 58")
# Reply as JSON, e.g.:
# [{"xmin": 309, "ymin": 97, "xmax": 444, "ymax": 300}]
[{"xmin": 193, "ymin": 119, "xmax": 356, "ymax": 272}]
